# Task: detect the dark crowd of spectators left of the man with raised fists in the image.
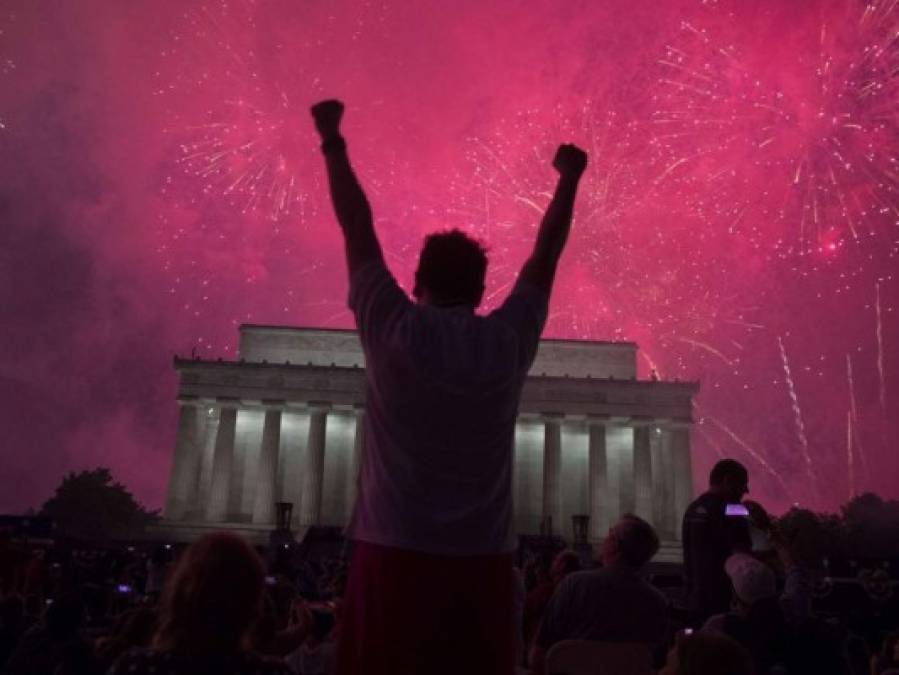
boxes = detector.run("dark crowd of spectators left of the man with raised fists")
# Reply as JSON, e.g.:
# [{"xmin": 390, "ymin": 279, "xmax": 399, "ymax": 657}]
[{"xmin": 0, "ymin": 533, "xmax": 346, "ymax": 675}]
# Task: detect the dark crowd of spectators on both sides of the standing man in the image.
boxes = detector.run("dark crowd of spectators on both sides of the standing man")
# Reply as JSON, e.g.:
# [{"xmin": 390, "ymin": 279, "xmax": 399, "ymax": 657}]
[{"xmin": 0, "ymin": 464, "xmax": 899, "ymax": 675}]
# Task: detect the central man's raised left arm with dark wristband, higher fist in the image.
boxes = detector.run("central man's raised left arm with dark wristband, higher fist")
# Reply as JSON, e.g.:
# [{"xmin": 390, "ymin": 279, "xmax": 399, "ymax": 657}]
[{"xmin": 311, "ymin": 100, "xmax": 384, "ymax": 274}]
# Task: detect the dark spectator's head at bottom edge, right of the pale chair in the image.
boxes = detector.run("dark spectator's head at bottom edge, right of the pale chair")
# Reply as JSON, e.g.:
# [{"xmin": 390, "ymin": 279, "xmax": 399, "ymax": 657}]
[{"xmin": 659, "ymin": 633, "xmax": 758, "ymax": 675}]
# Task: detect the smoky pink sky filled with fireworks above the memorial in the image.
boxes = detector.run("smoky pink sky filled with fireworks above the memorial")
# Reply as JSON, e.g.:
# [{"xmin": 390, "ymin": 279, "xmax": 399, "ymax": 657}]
[{"xmin": 0, "ymin": 0, "xmax": 899, "ymax": 512}]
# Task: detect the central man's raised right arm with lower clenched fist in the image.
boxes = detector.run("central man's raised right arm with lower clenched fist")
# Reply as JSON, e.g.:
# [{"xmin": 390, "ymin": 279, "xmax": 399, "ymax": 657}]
[{"xmin": 520, "ymin": 145, "xmax": 587, "ymax": 295}]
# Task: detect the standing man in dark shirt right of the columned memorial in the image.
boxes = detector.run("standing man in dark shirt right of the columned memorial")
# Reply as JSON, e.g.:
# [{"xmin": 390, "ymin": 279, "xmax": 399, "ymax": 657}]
[{"xmin": 682, "ymin": 459, "xmax": 752, "ymax": 625}]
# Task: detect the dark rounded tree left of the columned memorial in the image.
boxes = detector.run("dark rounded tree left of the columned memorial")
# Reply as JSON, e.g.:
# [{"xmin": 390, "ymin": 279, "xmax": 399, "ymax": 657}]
[{"xmin": 39, "ymin": 467, "xmax": 159, "ymax": 541}]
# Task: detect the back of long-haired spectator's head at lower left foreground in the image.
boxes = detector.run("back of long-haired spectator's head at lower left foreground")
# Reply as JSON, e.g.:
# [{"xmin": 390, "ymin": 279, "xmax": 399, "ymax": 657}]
[{"xmin": 153, "ymin": 532, "xmax": 265, "ymax": 655}]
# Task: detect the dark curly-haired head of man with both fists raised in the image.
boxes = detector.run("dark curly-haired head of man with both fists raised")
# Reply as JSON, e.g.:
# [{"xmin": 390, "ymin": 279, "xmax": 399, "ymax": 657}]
[{"xmin": 412, "ymin": 230, "xmax": 487, "ymax": 309}]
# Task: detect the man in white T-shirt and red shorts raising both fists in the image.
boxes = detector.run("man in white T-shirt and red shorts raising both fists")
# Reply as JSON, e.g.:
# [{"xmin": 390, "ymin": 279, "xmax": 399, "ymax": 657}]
[{"xmin": 312, "ymin": 101, "xmax": 587, "ymax": 675}]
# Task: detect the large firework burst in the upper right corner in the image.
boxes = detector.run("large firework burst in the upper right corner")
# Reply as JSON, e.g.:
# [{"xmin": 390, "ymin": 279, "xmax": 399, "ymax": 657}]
[{"xmin": 651, "ymin": 0, "xmax": 899, "ymax": 258}]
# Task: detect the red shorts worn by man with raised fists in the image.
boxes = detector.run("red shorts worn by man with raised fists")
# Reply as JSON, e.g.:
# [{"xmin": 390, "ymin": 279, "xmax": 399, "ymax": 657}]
[{"xmin": 337, "ymin": 542, "xmax": 516, "ymax": 675}]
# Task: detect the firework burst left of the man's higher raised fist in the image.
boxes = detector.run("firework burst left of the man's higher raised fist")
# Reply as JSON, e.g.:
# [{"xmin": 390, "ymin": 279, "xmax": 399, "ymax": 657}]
[{"xmin": 158, "ymin": 0, "xmax": 330, "ymax": 221}]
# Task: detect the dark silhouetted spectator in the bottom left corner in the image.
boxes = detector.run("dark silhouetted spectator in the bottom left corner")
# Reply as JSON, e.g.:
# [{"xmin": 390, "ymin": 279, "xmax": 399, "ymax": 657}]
[{"xmin": 3, "ymin": 594, "xmax": 98, "ymax": 675}]
